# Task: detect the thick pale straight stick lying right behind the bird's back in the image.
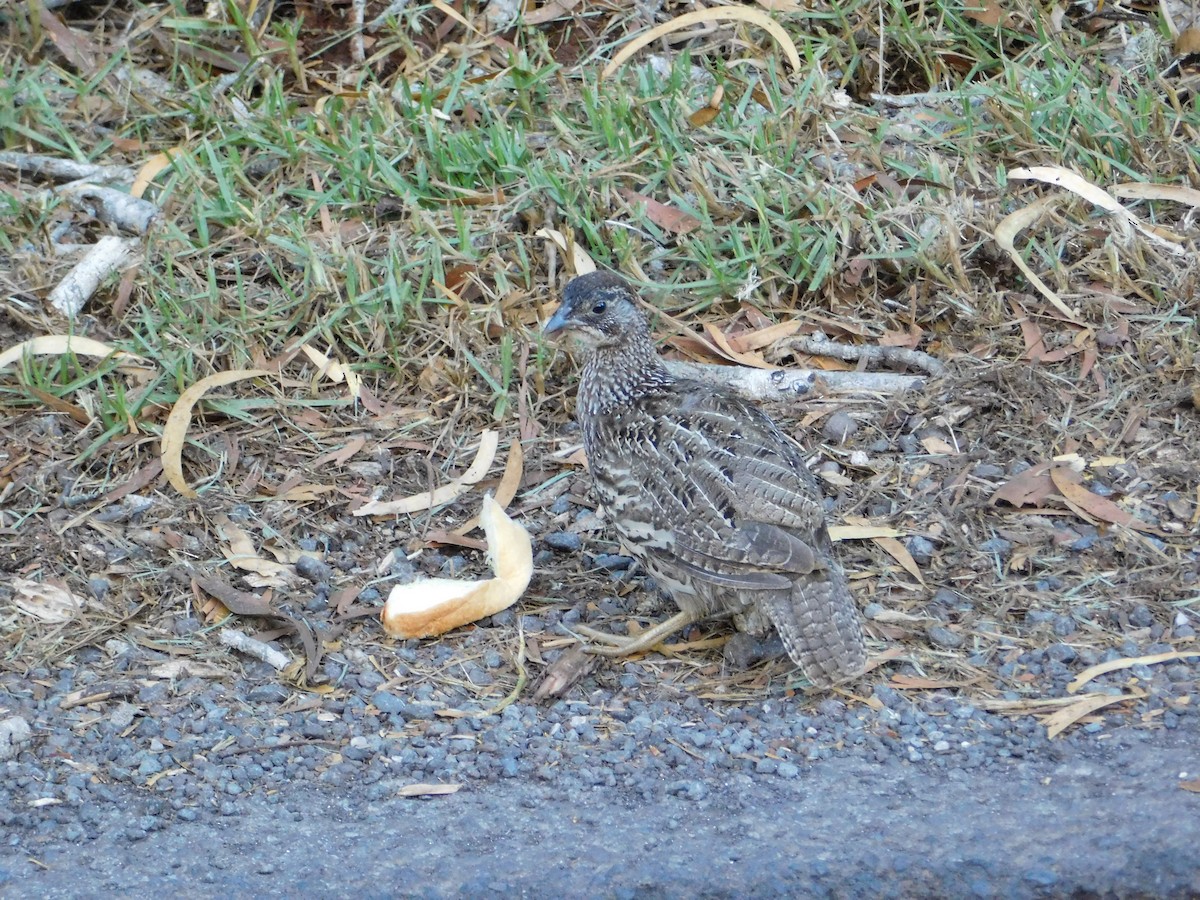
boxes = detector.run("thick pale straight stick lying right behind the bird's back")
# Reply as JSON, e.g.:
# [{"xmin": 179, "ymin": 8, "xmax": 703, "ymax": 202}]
[{"xmin": 666, "ymin": 360, "xmax": 925, "ymax": 402}]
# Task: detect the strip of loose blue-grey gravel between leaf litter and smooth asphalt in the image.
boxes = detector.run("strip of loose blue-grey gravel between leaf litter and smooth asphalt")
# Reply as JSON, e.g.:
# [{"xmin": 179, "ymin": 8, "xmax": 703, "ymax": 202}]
[{"xmin": 0, "ymin": 607, "xmax": 1200, "ymax": 895}]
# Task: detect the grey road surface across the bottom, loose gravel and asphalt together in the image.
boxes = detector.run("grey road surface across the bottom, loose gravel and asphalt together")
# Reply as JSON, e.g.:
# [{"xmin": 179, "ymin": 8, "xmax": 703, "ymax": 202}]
[{"xmin": 0, "ymin": 487, "xmax": 1200, "ymax": 898}]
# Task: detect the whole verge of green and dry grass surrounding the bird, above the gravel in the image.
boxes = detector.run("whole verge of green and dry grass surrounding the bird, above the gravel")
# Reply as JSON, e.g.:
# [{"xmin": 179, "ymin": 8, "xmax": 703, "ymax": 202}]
[{"xmin": 0, "ymin": 0, "xmax": 1200, "ymax": 703}]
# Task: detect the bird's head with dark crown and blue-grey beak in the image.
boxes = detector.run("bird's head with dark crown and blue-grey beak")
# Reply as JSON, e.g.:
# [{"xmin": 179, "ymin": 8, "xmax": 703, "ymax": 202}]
[{"xmin": 542, "ymin": 272, "xmax": 649, "ymax": 350}]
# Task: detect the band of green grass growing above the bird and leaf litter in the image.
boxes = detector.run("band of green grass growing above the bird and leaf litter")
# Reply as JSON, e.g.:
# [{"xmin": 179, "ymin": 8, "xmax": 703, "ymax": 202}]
[{"xmin": 0, "ymin": 0, "xmax": 1200, "ymax": 465}]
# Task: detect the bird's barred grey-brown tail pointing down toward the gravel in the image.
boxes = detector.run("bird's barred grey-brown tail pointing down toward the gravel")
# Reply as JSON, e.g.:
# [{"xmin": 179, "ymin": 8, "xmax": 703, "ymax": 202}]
[{"xmin": 764, "ymin": 571, "xmax": 866, "ymax": 688}]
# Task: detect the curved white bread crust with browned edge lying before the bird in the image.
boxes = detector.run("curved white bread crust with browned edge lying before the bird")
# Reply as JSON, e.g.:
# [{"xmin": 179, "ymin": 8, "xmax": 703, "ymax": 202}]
[{"xmin": 382, "ymin": 496, "xmax": 533, "ymax": 638}]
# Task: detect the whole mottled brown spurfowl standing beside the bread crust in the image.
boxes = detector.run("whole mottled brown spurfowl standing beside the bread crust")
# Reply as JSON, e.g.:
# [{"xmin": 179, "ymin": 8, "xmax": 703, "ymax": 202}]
[{"xmin": 545, "ymin": 272, "xmax": 866, "ymax": 688}]
